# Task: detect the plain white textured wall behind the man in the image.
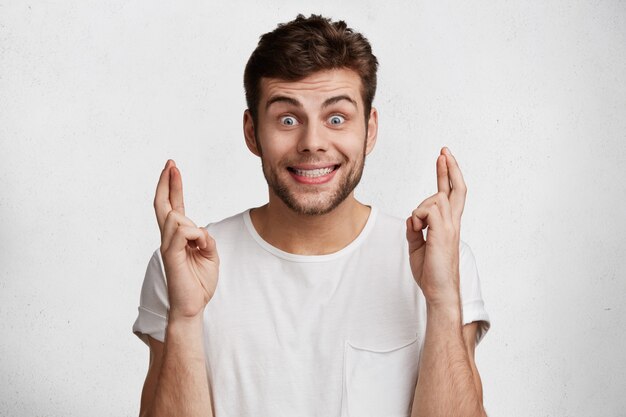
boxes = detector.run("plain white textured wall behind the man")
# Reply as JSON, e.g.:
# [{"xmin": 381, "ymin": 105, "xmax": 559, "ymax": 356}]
[{"xmin": 0, "ymin": 0, "xmax": 626, "ymax": 417}]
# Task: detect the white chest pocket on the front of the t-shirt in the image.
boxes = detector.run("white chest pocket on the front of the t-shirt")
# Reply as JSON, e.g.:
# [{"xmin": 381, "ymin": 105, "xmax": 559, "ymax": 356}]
[{"xmin": 344, "ymin": 337, "xmax": 419, "ymax": 417}]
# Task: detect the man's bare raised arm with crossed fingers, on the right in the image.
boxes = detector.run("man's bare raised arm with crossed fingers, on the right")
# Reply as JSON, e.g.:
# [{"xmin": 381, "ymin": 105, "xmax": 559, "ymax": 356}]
[{"xmin": 407, "ymin": 148, "xmax": 485, "ymax": 417}]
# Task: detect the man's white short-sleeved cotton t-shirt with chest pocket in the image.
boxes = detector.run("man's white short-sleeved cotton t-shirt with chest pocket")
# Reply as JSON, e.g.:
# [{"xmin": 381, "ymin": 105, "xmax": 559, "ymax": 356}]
[{"xmin": 133, "ymin": 208, "xmax": 489, "ymax": 417}]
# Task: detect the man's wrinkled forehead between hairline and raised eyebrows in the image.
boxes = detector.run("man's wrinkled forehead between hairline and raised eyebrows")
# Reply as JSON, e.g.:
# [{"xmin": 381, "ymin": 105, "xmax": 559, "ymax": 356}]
[{"xmin": 260, "ymin": 68, "xmax": 363, "ymax": 108}]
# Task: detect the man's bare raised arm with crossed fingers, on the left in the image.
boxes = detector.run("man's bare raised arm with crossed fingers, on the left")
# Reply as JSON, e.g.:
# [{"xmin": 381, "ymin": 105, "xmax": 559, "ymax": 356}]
[{"xmin": 140, "ymin": 161, "xmax": 219, "ymax": 417}]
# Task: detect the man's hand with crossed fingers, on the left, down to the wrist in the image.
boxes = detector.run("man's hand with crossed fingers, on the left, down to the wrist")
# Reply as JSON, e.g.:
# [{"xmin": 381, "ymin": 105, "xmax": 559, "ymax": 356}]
[{"xmin": 154, "ymin": 160, "xmax": 219, "ymax": 321}]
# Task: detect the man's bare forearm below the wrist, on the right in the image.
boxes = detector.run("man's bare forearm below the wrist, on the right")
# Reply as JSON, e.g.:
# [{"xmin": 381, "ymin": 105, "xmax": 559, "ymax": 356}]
[{"xmin": 411, "ymin": 305, "xmax": 485, "ymax": 417}]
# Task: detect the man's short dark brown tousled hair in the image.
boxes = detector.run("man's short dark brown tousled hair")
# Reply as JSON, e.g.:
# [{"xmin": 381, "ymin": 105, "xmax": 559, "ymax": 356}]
[{"xmin": 243, "ymin": 14, "xmax": 378, "ymax": 123}]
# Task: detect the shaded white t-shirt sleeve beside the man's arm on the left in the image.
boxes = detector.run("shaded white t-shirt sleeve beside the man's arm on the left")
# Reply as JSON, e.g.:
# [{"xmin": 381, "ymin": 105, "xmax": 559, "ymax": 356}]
[{"xmin": 133, "ymin": 249, "xmax": 169, "ymax": 344}]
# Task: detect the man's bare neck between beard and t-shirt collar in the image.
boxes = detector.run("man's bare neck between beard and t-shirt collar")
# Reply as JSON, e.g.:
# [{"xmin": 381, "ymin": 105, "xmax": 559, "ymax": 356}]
[{"xmin": 250, "ymin": 194, "xmax": 370, "ymax": 255}]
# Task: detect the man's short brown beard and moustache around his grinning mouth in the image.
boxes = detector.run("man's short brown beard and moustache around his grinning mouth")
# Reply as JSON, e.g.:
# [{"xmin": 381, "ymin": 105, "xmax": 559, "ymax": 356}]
[{"xmin": 261, "ymin": 139, "xmax": 365, "ymax": 216}]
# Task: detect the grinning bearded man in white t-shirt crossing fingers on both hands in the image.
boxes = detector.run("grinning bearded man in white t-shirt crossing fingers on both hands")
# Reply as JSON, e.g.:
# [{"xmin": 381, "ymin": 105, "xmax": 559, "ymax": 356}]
[{"xmin": 134, "ymin": 16, "xmax": 488, "ymax": 417}]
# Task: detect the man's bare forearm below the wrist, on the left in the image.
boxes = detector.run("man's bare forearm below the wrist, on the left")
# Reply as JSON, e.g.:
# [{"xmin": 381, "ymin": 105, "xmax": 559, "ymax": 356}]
[{"xmin": 148, "ymin": 319, "xmax": 213, "ymax": 417}]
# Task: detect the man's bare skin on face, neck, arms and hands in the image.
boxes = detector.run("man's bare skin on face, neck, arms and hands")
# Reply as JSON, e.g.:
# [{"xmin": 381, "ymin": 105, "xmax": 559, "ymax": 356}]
[{"xmin": 140, "ymin": 69, "xmax": 485, "ymax": 417}]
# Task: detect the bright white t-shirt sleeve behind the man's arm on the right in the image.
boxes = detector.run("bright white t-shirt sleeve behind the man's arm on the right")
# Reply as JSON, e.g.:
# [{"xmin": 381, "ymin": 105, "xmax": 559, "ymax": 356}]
[{"xmin": 459, "ymin": 241, "xmax": 491, "ymax": 344}]
